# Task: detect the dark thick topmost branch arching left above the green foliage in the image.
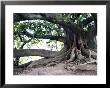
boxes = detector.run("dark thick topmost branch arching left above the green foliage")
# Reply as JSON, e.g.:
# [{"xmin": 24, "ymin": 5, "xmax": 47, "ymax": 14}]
[{"xmin": 14, "ymin": 13, "xmax": 83, "ymax": 35}]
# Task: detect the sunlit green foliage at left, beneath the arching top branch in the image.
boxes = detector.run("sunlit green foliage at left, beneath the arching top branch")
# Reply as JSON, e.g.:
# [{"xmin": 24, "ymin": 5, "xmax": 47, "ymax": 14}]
[{"xmin": 14, "ymin": 20, "xmax": 64, "ymax": 49}]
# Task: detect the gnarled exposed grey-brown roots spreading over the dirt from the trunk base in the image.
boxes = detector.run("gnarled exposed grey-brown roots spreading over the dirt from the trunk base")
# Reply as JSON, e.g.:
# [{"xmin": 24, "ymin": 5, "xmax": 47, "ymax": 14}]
[{"xmin": 15, "ymin": 44, "xmax": 97, "ymax": 74}]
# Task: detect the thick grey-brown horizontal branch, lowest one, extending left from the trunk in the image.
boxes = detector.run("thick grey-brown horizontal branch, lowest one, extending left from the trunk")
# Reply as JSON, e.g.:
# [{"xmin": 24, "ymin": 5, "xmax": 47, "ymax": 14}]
[{"xmin": 14, "ymin": 49, "xmax": 58, "ymax": 57}]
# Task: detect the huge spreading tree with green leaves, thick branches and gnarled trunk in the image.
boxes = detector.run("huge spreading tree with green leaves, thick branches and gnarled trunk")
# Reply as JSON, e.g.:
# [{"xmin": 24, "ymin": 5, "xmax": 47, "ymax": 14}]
[{"xmin": 13, "ymin": 13, "xmax": 97, "ymax": 66}]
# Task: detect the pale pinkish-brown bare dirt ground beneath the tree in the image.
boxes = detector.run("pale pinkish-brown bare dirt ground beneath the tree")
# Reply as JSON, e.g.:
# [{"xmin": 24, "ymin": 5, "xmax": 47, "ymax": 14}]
[{"xmin": 14, "ymin": 62, "xmax": 97, "ymax": 75}]
